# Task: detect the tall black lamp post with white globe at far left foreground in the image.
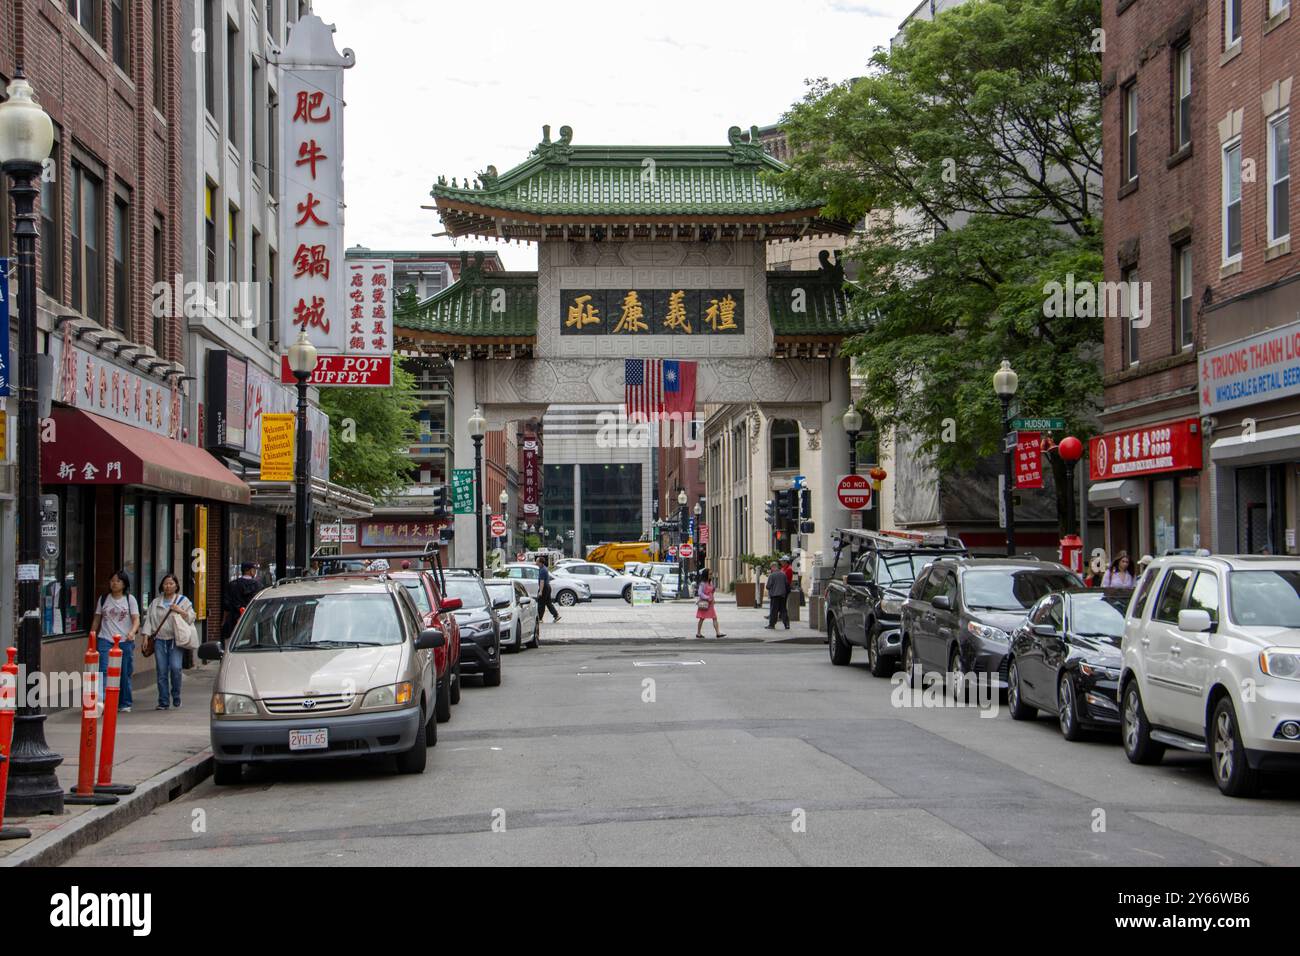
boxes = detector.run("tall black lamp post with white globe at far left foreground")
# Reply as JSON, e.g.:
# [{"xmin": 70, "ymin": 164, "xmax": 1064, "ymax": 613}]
[{"xmin": 0, "ymin": 69, "xmax": 64, "ymax": 817}]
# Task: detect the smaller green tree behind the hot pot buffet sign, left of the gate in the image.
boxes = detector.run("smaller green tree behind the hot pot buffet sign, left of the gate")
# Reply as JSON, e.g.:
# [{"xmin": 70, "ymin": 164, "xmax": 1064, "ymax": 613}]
[{"xmin": 321, "ymin": 356, "xmax": 420, "ymax": 501}]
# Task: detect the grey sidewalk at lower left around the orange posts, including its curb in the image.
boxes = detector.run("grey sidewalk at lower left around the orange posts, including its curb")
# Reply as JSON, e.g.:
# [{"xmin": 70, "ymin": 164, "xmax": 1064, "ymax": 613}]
[{"xmin": 0, "ymin": 663, "xmax": 217, "ymax": 866}]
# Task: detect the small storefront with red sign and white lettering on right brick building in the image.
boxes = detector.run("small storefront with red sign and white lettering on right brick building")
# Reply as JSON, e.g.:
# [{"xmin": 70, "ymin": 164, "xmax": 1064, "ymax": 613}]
[{"xmin": 1088, "ymin": 418, "xmax": 1206, "ymax": 562}]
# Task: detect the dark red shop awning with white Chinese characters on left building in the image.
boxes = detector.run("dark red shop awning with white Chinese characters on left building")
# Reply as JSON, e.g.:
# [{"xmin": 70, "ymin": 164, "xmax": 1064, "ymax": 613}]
[{"xmin": 40, "ymin": 408, "xmax": 248, "ymax": 505}]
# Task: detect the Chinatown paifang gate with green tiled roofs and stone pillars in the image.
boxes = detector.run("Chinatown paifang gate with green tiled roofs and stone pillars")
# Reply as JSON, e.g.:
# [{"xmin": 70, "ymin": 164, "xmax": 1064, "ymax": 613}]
[{"xmin": 394, "ymin": 126, "xmax": 859, "ymax": 563}]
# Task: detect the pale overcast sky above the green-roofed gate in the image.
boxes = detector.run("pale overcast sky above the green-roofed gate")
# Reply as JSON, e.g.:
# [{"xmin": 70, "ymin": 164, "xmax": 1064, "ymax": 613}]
[{"xmin": 332, "ymin": 0, "xmax": 917, "ymax": 269}]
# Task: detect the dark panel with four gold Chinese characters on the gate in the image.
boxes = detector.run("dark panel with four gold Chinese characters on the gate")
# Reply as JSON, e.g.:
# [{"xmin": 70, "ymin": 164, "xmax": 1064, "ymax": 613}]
[{"xmin": 560, "ymin": 289, "xmax": 745, "ymax": 336}]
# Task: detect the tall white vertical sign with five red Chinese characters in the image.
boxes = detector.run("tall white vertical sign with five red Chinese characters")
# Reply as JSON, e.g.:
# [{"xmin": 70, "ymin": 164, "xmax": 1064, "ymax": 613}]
[{"xmin": 276, "ymin": 13, "xmax": 355, "ymax": 369}]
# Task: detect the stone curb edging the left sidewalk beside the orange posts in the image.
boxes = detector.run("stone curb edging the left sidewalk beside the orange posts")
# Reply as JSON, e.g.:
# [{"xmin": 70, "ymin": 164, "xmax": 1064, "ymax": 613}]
[{"xmin": 0, "ymin": 750, "xmax": 212, "ymax": 868}]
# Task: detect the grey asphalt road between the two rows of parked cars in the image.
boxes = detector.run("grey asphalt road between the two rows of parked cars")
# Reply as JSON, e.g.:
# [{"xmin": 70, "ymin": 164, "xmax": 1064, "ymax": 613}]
[{"xmin": 69, "ymin": 624, "xmax": 1300, "ymax": 866}]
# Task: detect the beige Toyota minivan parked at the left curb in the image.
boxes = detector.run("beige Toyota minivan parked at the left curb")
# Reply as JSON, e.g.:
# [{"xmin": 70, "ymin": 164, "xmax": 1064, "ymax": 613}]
[{"xmin": 199, "ymin": 576, "xmax": 446, "ymax": 786}]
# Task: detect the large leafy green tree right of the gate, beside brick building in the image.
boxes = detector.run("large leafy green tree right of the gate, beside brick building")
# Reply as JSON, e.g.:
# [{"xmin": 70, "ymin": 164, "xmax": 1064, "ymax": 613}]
[{"xmin": 775, "ymin": 0, "xmax": 1102, "ymax": 530}]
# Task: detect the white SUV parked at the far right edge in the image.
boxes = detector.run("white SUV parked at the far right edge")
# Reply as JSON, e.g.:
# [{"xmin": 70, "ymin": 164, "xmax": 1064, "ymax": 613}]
[{"xmin": 1119, "ymin": 555, "xmax": 1300, "ymax": 796}]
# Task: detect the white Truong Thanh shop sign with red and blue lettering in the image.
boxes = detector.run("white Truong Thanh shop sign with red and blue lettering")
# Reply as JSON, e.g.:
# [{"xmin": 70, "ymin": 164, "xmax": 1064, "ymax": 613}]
[{"xmin": 1199, "ymin": 323, "xmax": 1300, "ymax": 415}]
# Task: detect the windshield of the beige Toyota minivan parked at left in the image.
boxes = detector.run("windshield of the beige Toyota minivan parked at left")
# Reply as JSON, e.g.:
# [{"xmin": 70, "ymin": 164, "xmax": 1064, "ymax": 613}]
[{"xmin": 230, "ymin": 592, "xmax": 403, "ymax": 650}]
